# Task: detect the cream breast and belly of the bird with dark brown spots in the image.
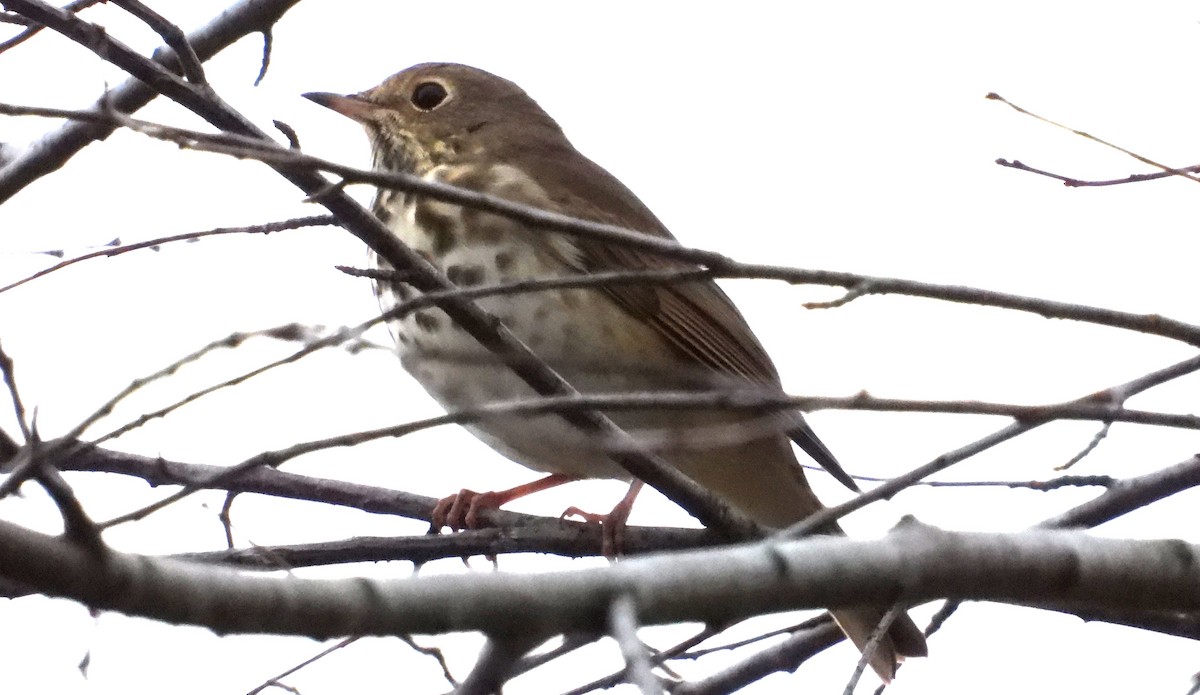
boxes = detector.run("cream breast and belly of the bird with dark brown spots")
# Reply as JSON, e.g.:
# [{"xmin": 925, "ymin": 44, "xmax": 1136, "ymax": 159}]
[{"xmin": 372, "ymin": 164, "xmax": 672, "ymax": 479}]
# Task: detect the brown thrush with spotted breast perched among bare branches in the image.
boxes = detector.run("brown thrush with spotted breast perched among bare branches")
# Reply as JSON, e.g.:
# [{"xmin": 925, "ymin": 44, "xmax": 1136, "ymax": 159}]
[{"xmin": 305, "ymin": 64, "xmax": 925, "ymax": 679}]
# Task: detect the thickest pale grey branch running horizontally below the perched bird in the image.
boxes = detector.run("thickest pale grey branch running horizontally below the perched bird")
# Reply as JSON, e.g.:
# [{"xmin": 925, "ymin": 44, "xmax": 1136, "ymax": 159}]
[{"xmin": 0, "ymin": 522, "xmax": 1200, "ymax": 637}]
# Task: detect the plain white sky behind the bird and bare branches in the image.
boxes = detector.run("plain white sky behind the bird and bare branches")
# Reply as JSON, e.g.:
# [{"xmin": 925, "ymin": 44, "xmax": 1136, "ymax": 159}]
[{"xmin": 0, "ymin": 0, "xmax": 1200, "ymax": 695}]
